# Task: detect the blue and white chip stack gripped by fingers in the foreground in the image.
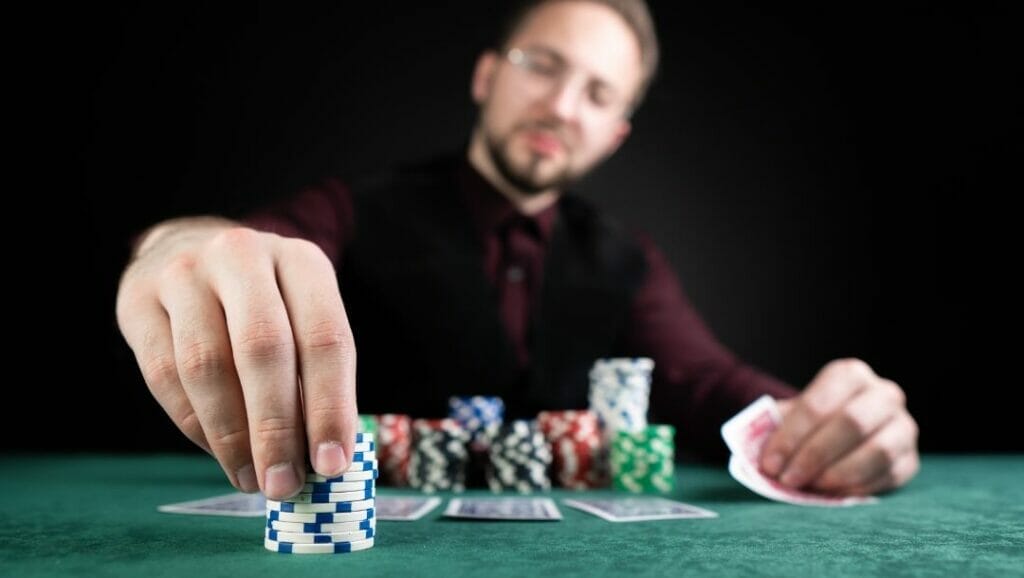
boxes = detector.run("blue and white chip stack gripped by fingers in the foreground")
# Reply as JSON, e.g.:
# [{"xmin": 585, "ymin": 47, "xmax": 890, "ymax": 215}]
[{"xmin": 263, "ymin": 434, "xmax": 378, "ymax": 553}]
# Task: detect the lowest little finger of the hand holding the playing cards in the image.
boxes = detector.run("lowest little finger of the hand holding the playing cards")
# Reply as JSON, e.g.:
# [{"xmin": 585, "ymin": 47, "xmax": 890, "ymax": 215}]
[{"xmin": 813, "ymin": 411, "xmax": 920, "ymax": 495}]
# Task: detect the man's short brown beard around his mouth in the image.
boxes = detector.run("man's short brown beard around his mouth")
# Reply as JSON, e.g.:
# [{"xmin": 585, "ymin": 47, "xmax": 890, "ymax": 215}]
[{"xmin": 483, "ymin": 122, "xmax": 582, "ymax": 196}]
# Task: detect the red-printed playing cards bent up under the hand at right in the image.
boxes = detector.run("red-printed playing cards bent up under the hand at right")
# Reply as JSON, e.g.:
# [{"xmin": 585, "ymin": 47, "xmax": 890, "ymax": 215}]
[{"xmin": 722, "ymin": 396, "xmax": 878, "ymax": 506}]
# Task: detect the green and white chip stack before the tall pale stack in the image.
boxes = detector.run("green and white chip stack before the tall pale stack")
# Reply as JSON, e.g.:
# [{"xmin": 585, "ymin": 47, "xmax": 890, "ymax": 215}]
[{"xmin": 609, "ymin": 425, "xmax": 676, "ymax": 493}]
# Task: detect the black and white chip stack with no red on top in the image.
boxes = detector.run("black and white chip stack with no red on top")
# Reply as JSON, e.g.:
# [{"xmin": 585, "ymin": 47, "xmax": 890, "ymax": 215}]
[{"xmin": 486, "ymin": 419, "xmax": 551, "ymax": 494}]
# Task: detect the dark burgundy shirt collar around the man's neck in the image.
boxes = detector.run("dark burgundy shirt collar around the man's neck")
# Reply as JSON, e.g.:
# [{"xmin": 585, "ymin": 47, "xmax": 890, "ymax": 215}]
[{"xmin": 459, "ymin": 160, "xmax": 558, "ymax": 244}]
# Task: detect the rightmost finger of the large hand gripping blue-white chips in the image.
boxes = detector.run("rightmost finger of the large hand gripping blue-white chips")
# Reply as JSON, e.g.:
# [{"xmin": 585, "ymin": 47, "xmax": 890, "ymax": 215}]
[{"xmin": 275, "ymin": 241, "xmax": 357, "ymax": 476}]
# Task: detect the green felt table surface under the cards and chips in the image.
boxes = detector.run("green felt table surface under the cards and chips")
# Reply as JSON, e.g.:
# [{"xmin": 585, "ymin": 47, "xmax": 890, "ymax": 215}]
[{"xmin": 0, "ymin": 455, "xmax": 1024, "ymax": 578}]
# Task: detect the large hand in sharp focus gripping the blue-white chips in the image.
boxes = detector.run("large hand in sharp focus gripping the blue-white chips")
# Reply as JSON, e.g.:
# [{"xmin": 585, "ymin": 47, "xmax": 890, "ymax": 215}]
[{"xmin": 117, "ymin": 217, "xmax": 357, "ymax": 499}]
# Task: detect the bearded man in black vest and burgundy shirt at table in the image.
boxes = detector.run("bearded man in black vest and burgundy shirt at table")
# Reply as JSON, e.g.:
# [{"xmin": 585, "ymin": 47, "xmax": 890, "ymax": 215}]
[{"xmin": 117, "ymin": 0, "xmax": 919, "ymax": 498}]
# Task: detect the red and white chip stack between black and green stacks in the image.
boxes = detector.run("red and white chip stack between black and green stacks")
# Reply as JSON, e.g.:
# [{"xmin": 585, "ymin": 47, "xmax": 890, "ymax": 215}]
[{"xmin": 537, "ymin": 410, "xmax": 607, "ymax": 490}]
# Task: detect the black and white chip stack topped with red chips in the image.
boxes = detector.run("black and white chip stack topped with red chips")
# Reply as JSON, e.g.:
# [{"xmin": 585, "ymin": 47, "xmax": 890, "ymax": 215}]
[{"xmin": 409, "ymin": 418, "xmax": 469, "ymax": 493}]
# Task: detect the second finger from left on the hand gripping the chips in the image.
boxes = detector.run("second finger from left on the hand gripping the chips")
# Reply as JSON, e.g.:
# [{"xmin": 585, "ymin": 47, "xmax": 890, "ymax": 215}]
[{"xmin": 160, "ymin": 259, "xmax": 259, "ymax": 492}]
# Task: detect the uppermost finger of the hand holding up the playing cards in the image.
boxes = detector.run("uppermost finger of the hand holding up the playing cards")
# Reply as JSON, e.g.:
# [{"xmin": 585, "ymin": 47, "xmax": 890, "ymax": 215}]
[{"xmin": 761, "ymin": 360, "xmax": 877, "ymax": 484}]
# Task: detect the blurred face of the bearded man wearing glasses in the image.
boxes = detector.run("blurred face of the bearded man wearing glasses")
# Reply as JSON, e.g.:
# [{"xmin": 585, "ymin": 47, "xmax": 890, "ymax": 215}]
[{"xmin": 473, "ymin": 1, "xmax": 641, "ymax": 194}]
